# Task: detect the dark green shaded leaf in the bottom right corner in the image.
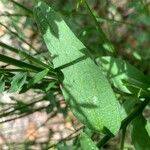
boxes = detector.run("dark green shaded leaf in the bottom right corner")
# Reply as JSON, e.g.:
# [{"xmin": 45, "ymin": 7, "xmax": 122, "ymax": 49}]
[{"xmin": 131, "ymin": 115, "xmax": 150, "ymax": 150}]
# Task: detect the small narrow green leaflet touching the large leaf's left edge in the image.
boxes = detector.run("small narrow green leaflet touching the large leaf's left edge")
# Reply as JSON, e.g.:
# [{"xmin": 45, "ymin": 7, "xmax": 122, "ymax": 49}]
[{"xmin": 28, "ymin": 69, "xmax": 49, "ymax": 87}]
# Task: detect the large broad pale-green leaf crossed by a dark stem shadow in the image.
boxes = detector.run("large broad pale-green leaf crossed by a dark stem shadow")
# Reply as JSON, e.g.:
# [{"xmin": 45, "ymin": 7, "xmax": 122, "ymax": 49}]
[{"xmin": 34, "ymin": 2, "xmax": 121, "ymax": 134}]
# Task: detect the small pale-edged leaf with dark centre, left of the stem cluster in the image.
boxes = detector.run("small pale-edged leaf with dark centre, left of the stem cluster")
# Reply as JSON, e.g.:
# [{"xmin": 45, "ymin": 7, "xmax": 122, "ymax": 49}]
[{"xmin": 9, "ymin": 73, "xmax": 27, "ymax": 92}]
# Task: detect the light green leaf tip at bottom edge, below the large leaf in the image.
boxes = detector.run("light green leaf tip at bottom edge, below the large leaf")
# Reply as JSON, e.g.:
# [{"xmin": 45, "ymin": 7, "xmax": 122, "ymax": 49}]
[{"xmin": 79, "ymin": 132, "xmax": 99, "ymax": 150}]
